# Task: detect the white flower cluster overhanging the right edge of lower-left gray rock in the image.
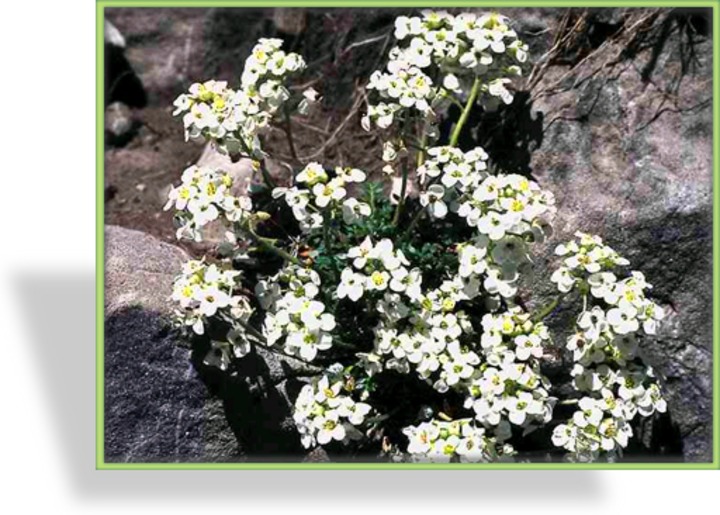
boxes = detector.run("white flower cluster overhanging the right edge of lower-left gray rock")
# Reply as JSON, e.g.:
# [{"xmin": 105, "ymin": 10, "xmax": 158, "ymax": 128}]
[{"xmin": 171, "ymin": 260, "xmax": 252, "ymax": 334}]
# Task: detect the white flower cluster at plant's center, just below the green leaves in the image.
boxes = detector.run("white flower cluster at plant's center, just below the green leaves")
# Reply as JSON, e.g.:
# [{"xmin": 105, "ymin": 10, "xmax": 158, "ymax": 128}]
[{"xmin": 337, "ymin": 236, "xmax": 422, "ymax": 302}]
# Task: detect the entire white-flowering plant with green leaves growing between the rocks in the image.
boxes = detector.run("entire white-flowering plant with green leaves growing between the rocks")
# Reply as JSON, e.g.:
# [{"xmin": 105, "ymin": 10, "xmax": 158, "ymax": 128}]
[{"xmin": 165, "ymin": 18, "xmax": 667, "ymax": 462}]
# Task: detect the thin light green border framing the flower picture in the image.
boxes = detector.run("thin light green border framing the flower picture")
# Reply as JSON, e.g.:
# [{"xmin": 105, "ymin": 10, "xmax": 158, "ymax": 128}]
[{"xmin": 95, "ymin": 0, "xmax": 720, "ymax": 470}]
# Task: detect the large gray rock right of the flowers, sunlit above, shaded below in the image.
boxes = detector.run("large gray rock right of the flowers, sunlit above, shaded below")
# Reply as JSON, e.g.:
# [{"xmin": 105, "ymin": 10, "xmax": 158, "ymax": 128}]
[{"xmin": 516, "ymin": 13, "xmax": 712, "ymax": 461}]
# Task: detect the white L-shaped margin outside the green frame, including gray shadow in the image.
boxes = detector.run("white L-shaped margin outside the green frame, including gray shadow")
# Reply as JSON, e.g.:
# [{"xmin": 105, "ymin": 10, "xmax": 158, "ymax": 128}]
[{"xmin": 0, "ymin": 0, "xmax": 720, "ymax": 515}]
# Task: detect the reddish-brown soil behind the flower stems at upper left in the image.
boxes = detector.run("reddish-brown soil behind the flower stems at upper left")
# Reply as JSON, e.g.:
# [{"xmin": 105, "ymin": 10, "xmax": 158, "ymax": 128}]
[{"xmin": 105, "ymin": 8, "xmax": 389, "ymax": 255}]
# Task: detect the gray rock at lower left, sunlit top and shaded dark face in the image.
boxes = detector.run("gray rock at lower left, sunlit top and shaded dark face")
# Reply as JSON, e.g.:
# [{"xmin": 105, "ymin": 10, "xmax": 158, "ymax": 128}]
[{"xmin": 105, "ymin": 226, "xmax": 241, "ymax": 462}]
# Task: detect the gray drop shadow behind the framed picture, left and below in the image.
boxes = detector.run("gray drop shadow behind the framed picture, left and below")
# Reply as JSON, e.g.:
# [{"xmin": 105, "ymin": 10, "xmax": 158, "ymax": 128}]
[{"xmin": 12, "ymin": 270, "xmax": 606, "ymax": 507}]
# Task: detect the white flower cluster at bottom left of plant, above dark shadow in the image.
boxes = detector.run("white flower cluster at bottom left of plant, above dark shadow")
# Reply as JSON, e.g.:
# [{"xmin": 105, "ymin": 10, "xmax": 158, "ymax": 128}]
[{"xmin": 293, "ymin": 365, "xmax": 371, "ymax": 448}]
